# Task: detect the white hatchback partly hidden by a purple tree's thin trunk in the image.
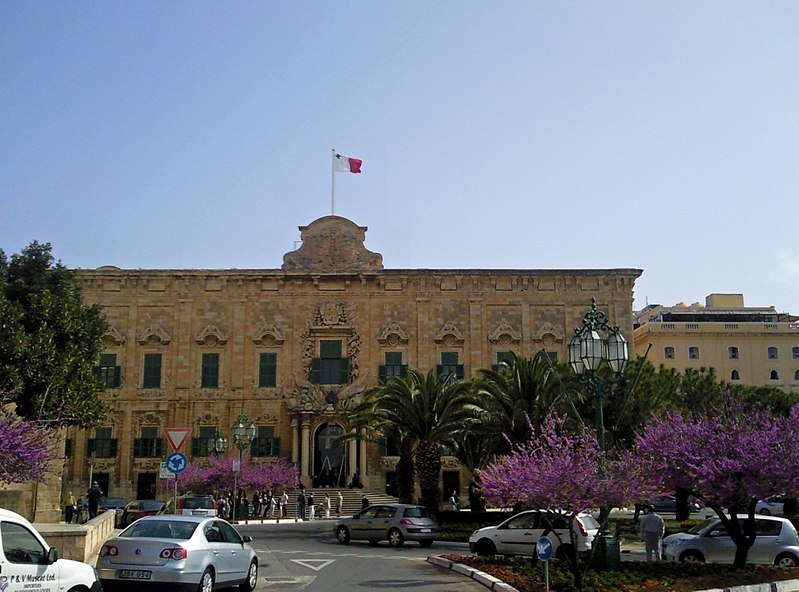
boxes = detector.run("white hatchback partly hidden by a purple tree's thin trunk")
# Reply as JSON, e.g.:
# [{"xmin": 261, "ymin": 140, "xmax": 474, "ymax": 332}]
[{"xmin": 469, "ymin": 510, "xmax": 599, "ymax": 558}]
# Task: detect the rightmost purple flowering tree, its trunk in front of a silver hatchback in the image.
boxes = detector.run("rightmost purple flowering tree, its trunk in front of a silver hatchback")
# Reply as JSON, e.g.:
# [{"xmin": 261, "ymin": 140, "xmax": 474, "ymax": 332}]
[{"xmin": 632, "ymin": 402, "xmax": 799, "ymax": 567}]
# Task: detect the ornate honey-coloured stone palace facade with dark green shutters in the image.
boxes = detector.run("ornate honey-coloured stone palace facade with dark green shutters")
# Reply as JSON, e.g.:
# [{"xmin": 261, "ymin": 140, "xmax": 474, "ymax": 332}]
[{"xmin": 64, "ymin": 216, "xmax": 641, "ymax": 499}]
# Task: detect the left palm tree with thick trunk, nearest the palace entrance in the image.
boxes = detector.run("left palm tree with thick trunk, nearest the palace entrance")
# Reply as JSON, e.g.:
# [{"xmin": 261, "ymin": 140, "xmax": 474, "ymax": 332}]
[{"xmin": 358, "ymin": 369, "xmax": 479, "ymax": 514}]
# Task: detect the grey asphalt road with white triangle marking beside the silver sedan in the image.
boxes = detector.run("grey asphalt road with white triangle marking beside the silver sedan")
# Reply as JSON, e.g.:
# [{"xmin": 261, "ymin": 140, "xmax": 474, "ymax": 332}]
[{"xmin": 237, "ymin": 520, "xmax": 486, "ymax": 592}]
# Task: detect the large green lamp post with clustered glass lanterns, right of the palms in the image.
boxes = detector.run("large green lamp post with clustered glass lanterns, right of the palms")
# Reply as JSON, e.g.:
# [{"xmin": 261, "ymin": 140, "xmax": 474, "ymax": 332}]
[{"xmin": 569, "ymin": 298, "xmax": 630, "ymax": 569}]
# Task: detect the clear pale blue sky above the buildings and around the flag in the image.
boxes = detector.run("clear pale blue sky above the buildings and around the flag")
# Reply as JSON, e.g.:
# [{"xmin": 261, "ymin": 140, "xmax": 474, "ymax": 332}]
[{"xmin": 0, "ymin": 0, "xmax": 799, "ymax": 314}]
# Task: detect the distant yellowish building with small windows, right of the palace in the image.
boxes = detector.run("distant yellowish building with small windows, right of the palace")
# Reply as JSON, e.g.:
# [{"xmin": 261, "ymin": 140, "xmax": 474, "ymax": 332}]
[{"xmin": 634, "ymin": 294, "xmax": 799, "ymax": 392}]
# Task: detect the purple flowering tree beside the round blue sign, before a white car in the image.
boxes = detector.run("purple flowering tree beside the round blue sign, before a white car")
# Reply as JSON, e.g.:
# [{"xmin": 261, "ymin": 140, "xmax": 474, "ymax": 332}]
[{"xmin": 477, "ymin": 415, "xmax": 652, "ymax": 589}]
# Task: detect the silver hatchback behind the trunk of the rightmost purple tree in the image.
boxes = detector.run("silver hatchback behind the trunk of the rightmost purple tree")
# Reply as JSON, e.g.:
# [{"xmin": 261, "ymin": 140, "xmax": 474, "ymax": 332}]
[{"xmin": 663, "ymin": 515, "xmax": 799, "ymax": 566}]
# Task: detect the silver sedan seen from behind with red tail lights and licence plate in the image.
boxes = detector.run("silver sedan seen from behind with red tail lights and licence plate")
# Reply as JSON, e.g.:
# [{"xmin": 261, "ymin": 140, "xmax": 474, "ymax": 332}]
[{"xmin": 97, "ymin": 515, "xmax": 258, "ymax": 592}]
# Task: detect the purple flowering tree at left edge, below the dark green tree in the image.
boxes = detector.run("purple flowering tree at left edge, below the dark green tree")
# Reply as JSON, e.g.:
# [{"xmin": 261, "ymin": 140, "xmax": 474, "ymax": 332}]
[{"xmin": 0, "ymin": 407, "xmax": 58, "ymax": 487}]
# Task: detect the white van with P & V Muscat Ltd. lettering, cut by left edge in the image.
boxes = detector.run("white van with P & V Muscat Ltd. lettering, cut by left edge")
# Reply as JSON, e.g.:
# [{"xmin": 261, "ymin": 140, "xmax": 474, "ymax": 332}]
[{"xmin": 0, "ymin": 508, "xmax": 103, "ymax": 592}]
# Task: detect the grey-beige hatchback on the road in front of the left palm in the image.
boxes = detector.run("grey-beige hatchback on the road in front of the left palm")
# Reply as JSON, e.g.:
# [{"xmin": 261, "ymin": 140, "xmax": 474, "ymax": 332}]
[{"xmin": 334, "ymin": 504, "xmax": 438, "ymax": 547}]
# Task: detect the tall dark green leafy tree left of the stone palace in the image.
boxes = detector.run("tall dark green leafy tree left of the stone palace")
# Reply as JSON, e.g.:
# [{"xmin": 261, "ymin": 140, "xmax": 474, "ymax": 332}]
[{"xmin": 0, "ymin": 241, "xmax": 107, "ymax": 428}]
